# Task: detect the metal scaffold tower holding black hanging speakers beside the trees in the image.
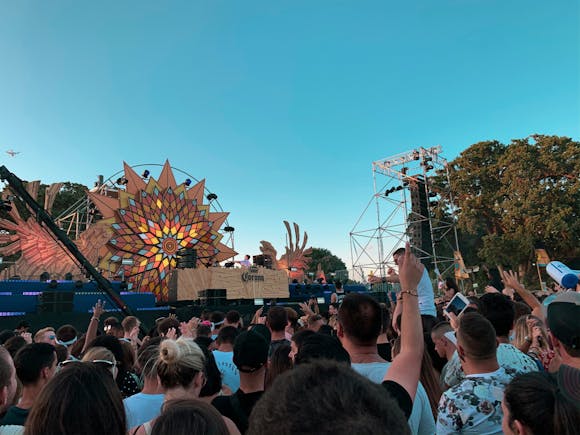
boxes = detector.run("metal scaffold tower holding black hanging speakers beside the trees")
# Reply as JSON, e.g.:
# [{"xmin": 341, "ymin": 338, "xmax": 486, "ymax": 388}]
[{"xmin": 350, "ymin": 146, "xmax": 460, "ymax": 282}]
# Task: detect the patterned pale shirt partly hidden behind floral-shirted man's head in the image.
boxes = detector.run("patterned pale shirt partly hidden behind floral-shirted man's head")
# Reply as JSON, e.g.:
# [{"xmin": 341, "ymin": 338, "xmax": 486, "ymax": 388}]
[{"xmin": 444, "ymin": 343, "xmax": 538, "ymax": 387}]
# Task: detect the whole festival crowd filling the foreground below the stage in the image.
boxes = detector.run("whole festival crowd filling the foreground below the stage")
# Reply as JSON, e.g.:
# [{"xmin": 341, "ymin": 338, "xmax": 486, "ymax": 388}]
[{"xmin": 0, "ymin": 246, "xmax": 580, "ymax": 435}]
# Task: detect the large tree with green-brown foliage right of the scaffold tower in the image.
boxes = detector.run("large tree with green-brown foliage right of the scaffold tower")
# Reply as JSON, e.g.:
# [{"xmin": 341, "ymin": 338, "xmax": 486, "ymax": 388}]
[{"xmin": 449, "ymin": 135, "xmax": 580, "ymax": 270}]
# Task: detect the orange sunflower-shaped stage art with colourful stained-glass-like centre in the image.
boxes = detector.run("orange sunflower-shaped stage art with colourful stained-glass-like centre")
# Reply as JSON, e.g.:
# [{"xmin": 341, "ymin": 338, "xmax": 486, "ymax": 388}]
[{"xmin": 89, "ymin": 161, "xmax": 236, "ymax": 301}]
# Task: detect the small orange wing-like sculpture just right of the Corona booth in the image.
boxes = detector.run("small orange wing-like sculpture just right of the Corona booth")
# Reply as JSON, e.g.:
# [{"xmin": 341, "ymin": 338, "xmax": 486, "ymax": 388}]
[{"xmin": 260, "ymin": 221, "xmax": 312, "ymax": 281}]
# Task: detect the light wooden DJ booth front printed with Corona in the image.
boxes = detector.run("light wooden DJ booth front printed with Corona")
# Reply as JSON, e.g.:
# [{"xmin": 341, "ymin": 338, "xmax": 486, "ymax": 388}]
[{"xmin": 169, "ymin": 266, "xmax": 290, "ymax": 301}]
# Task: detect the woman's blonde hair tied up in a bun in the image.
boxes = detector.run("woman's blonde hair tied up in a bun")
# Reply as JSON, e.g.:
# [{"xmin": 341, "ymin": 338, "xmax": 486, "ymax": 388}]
[{"xmin": 157, "ymin": 337, "xmax": 205, "ymax": 388}]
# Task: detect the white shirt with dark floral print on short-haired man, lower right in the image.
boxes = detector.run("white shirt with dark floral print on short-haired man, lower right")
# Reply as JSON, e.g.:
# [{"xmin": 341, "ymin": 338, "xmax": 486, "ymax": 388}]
[{"xmin": 437, "ymin": 367, "xmax": 517, "ymax": 435}]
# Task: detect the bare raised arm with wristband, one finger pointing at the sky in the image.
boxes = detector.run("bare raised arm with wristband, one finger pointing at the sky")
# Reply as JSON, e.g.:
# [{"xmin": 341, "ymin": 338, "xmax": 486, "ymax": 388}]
[{"xmin": 384, "ymin": 243, "xmax": 425, "ymax": 400}]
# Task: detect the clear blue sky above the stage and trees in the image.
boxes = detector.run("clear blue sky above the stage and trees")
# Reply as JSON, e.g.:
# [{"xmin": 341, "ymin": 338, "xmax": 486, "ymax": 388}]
[{"xmin": 0, "ymin": 0, "xmax": 580, "ymax": 272}]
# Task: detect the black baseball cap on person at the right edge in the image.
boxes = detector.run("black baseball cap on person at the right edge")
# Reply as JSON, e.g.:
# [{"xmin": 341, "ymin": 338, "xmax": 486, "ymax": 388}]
[{"xmin": 548, "ymin": 291, "xmax": 580, "ymax": 349}]
